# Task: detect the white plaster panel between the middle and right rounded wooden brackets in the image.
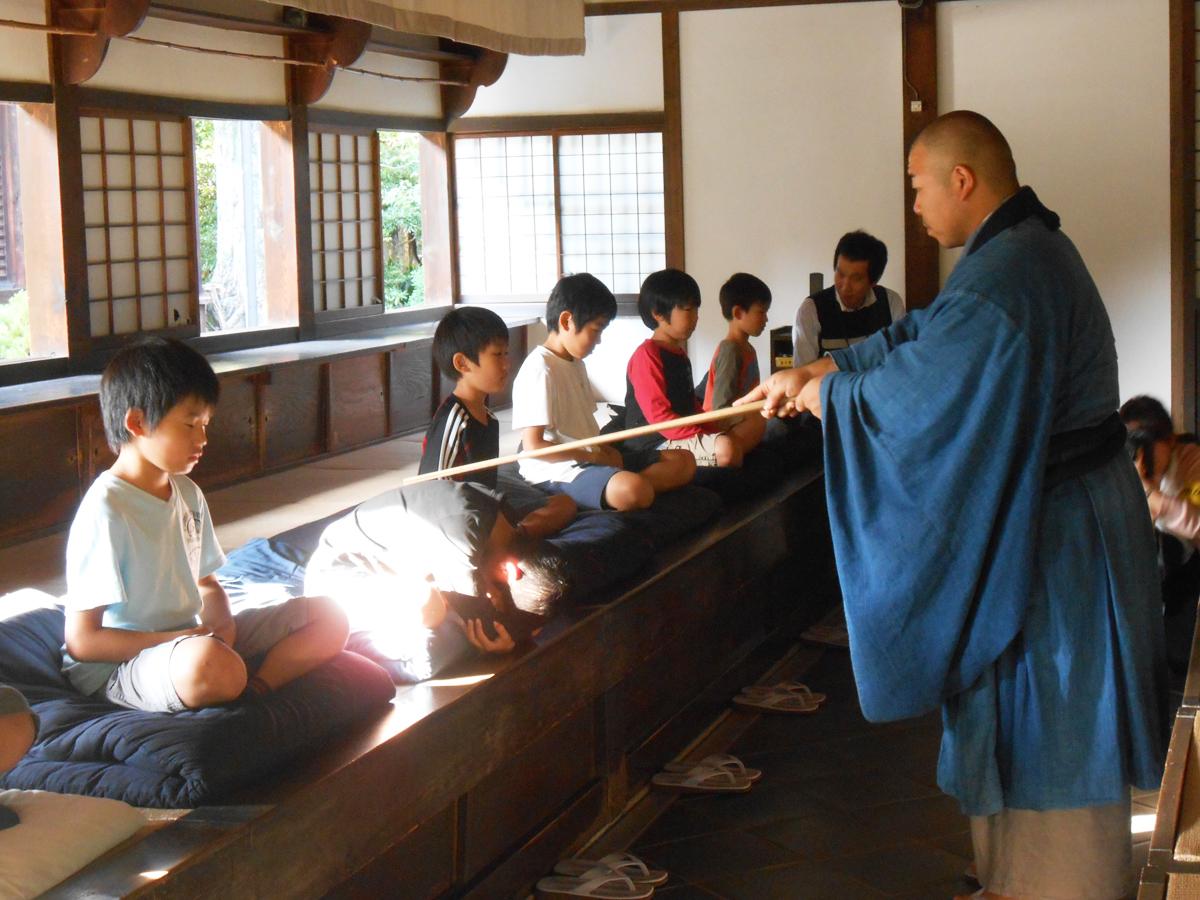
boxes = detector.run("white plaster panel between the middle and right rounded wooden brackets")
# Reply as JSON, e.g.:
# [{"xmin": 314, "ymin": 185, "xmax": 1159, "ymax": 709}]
[{"xmin": 313, "ymin": 53, "xmax": 442, "ymax": 119}]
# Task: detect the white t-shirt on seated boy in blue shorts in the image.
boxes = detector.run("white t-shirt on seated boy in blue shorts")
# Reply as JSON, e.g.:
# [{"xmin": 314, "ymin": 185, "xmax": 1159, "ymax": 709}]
[{"xmin": 512, "ymin": 347, "xmax": 600, "ymax": 485}]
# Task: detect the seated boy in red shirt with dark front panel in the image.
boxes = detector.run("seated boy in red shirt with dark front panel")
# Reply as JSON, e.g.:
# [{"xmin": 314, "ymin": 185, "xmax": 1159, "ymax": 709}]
[{"xmin": 625, "ymin": 269, "xmax": 744, "ymax": 466}]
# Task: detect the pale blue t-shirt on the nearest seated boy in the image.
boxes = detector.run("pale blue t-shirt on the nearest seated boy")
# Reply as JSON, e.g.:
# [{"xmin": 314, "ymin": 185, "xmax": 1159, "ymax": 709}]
[{"xmin": 62, "ymin": 472, "xmax": 226, "ymax": 694}]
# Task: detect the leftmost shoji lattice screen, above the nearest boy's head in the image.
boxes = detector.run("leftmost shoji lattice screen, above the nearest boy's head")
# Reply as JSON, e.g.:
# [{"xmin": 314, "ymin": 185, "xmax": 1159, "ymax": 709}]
[{"xmin": 80, "ymin": 113, "xmax": 197, "ymax": 337}]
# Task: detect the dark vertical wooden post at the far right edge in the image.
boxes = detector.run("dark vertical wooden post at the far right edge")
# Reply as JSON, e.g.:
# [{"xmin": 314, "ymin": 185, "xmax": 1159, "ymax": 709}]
[{"xmin": 1169, "ymin": 0, "xmax": 1200, "ymax": 431}]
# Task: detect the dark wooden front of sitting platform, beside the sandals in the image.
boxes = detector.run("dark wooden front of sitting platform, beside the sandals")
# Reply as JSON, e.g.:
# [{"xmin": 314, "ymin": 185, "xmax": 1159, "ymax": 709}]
[{"xmin": 48, "ymin": 464, "xmax": 838, "ymax": 898}]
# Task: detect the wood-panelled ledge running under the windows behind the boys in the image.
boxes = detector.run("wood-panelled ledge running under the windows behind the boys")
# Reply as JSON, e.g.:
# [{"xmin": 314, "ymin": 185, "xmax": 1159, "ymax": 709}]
[{"xmin": 0, "ymin": 317, "xmax": 534, "ymax": 546}]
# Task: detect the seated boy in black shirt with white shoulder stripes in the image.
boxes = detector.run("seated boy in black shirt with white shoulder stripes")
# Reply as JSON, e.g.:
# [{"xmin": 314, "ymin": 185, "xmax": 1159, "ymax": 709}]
[{"xmin": 418, "ymin": 306, "xmax": 576, "ymax": 536}]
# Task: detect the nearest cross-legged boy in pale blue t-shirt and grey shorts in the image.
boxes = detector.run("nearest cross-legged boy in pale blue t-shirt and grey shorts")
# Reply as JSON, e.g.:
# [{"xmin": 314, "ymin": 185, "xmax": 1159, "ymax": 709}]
[{"xmin": 62, "ymin": 338, "xmax": 347, "ymax": 713}]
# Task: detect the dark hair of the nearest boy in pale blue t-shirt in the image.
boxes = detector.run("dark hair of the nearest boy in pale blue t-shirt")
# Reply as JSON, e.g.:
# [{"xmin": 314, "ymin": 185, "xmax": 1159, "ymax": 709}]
[{"xmin": 100, "ymin": 337, "xmax": 221, "ymax": 454}]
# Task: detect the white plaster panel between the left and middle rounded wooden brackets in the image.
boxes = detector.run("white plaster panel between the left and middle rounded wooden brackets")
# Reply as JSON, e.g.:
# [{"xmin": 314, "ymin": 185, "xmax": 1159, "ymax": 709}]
[{"xmin": 88, "ymin": 18, "xmax": 287, "ymax": 104}]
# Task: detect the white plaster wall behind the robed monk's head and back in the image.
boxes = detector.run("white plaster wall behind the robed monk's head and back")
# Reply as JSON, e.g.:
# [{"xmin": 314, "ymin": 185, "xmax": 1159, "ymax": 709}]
[{"xmin": 937, "ymin": 0, "xmax": 1171, "ymax": 408}]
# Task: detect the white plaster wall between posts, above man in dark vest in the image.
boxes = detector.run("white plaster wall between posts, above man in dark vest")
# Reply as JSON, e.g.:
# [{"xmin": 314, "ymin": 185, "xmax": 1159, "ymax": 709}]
[{"xmin": 680, "ymin": 0, "xmax": 905, "ymax": 379}]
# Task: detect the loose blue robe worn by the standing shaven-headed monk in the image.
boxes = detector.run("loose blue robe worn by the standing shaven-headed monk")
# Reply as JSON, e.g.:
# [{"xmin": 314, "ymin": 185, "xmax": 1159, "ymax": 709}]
[{"xmin": 821, "ymin": 188, "xmax": 1169, "ymax": 815}]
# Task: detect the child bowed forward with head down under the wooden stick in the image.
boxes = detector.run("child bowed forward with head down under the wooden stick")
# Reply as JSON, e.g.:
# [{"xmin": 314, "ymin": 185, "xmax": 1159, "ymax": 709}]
[{"xmin": 305, "ymin": 479, "xmax": 566, "ymax": 659}]
